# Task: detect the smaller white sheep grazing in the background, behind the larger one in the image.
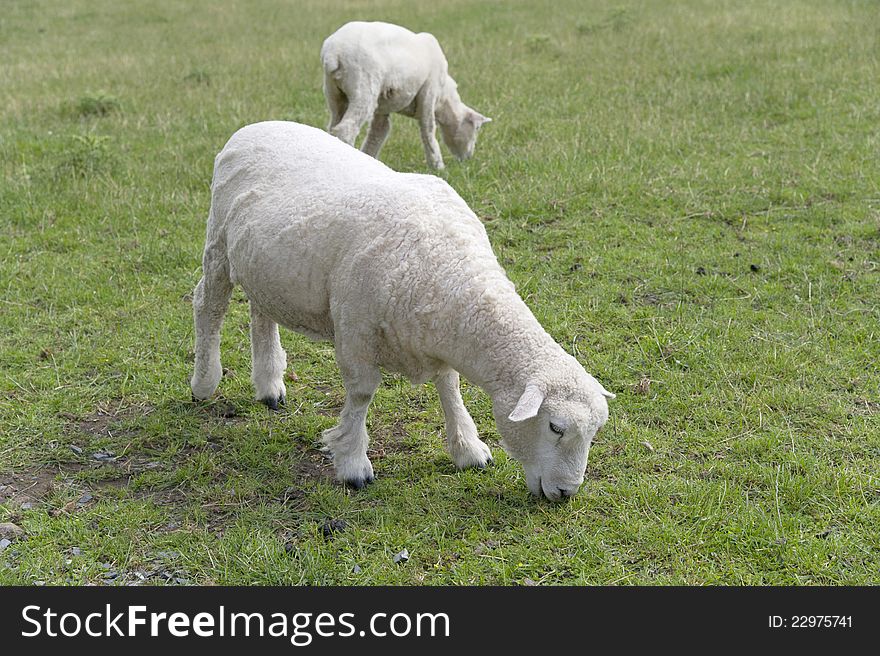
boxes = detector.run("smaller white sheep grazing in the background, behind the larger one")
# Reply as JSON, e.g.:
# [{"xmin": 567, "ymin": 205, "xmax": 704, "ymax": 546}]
[{"xmin": 321, "ymin": 21, "xmax": 492, "ymax": 169}]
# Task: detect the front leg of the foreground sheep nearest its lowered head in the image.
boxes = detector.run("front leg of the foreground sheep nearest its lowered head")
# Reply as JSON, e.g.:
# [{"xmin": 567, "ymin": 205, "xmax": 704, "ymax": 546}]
[{"xmin": 434, "ymin": 369, "xmax": 492, "ymax": 469}]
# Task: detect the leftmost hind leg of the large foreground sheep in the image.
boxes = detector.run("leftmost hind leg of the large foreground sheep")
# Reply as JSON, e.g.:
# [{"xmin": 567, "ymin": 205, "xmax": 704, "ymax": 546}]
[{"xmin": 190, "ymin": 255, "xmax": 232, "ymax": 399}]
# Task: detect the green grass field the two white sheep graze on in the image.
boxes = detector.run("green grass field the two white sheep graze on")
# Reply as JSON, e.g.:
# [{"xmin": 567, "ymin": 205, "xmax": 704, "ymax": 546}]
[{"xmin": 0, "ymin": 0, "xmax": 880, "ymax": 585}]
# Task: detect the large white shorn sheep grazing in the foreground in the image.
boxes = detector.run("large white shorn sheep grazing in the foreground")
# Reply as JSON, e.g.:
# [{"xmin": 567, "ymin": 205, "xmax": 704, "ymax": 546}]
[{"xmin": 191, "ymin": 121, "xmax": 614, "ymax": 499}]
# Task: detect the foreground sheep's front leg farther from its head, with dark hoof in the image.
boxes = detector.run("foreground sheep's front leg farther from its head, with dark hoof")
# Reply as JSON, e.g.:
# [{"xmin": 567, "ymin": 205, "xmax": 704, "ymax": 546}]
[{"xmin": 321, "ymin": 354, "xmax": 382, "ymax": 489}]
